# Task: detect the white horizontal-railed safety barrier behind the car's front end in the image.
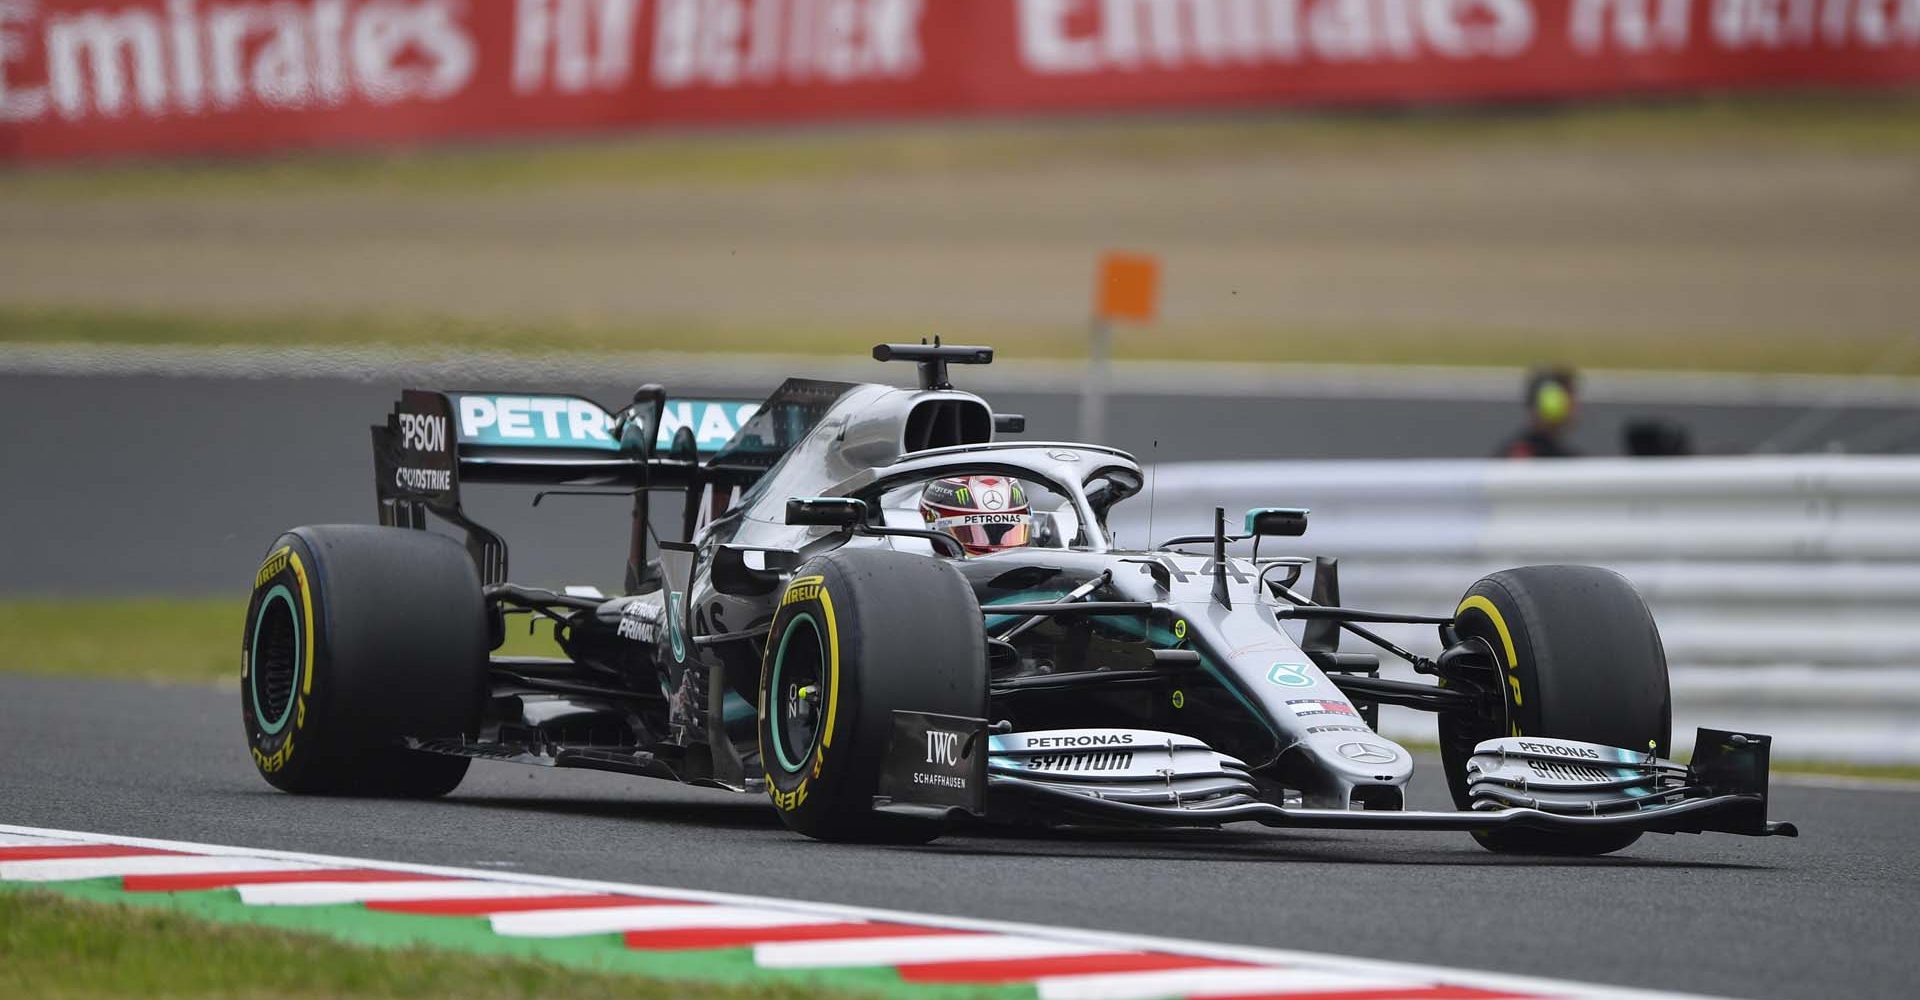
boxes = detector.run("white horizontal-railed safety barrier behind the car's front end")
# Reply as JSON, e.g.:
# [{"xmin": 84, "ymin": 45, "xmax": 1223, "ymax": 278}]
[{"xmin": 1116, "ymin": 455, "xmax": 1920, "ymax": 762}]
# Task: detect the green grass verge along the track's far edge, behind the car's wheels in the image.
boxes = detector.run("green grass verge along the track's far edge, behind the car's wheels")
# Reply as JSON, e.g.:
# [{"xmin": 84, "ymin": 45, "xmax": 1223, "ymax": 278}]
[{"xmin": 0, "ymin": 597, "xmax": 1920, "ymax": 779}]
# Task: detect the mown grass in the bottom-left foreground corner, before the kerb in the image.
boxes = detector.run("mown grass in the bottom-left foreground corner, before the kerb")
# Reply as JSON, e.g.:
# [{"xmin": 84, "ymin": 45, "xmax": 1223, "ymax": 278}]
[{"xmin": 0, "ymin": 893, "xmax": 864, "ymax": 1000}]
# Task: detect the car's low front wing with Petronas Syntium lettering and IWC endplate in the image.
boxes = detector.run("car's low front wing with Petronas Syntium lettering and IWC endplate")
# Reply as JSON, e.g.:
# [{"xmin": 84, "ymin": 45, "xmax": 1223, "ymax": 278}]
[{"xmin": 876, "ymin": 712, "xmax": 1799, "ymax": 837}]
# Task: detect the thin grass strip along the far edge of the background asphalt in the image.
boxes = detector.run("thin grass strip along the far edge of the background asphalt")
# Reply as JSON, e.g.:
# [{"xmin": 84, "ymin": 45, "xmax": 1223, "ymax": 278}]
[{"xmin": 0, "ymin": 303, "xmax": 1920, "ymax": 374}]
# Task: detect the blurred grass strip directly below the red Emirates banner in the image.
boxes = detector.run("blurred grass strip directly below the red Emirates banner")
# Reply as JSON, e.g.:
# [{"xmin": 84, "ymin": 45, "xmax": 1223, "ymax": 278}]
[{"xmin": 11, "ymin": 94, "xmax": 1920, "ymax": 198}]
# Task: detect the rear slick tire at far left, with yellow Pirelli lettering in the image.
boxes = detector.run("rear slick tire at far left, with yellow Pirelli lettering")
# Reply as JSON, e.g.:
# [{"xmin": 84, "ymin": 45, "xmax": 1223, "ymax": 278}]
[{"xmin": 240, "ymin": 524, "xmax": 488, "ymax": 798}]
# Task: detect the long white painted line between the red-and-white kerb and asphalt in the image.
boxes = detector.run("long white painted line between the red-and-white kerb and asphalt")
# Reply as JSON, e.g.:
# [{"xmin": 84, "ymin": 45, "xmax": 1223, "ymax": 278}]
[{"xmin": 0, "ymin": 823, "xmax": 1728, "ymax": 1000}]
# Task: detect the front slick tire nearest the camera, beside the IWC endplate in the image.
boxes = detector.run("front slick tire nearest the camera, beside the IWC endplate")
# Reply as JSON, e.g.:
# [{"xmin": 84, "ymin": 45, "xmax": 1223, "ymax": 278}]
[{"xmin": 758, "ymin": 549, "xmax": 987, "ymax": 843}]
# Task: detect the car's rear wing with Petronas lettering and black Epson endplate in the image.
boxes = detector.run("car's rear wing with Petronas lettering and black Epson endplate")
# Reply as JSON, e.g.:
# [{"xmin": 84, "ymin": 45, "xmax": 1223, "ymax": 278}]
[{"xmin": 372, "ymin": 386, "xmax": 760, "ymax": 583}]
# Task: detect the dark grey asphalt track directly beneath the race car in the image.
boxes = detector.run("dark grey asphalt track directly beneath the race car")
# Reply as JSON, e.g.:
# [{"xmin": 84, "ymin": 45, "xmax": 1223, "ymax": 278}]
[{"xmin": 0, "ymin": 676, "xmax": 1920, "ymax": 1000}]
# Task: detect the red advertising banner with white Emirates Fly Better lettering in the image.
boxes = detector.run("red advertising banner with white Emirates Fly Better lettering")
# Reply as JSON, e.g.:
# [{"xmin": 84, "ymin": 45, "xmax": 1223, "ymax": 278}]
[{"xmin": 0, "ymin": 0, "xmax": 1920, "ymax": 163}]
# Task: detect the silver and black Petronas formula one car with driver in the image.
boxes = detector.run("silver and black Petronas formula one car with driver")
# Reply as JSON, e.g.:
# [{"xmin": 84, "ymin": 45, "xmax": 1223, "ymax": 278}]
[{"xmin": 240, "ymin": 344, "xmax": 1795, "ymax": 854}]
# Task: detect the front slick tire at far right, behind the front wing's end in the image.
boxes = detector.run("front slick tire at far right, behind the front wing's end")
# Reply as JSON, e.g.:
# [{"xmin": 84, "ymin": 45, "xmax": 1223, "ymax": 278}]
[{"xmin": 1440, "ymin": 566, "xmax": 1672, "ymax": 854}]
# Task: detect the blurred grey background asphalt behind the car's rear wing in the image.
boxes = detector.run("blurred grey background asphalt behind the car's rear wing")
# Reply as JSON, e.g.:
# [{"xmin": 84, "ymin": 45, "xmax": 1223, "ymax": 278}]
[{"xmin": 0, "ymin": 365, "xmax": 1920, "ymax": 595}]
